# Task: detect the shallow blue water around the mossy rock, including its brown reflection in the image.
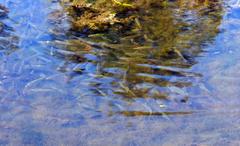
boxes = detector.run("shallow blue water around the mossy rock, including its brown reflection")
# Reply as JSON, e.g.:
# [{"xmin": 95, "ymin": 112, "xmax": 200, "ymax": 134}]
[{"xmin": 0, "ymin": 0, "xmax": 240, "ymax": 145}]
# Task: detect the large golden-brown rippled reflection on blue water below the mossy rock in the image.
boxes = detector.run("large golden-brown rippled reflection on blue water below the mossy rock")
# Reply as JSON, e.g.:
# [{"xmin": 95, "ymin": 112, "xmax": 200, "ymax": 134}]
[{"xmin": 48, "ymin": 1, "xmax": 223, "ymax": 112}]
